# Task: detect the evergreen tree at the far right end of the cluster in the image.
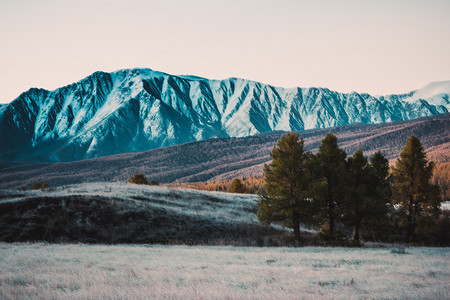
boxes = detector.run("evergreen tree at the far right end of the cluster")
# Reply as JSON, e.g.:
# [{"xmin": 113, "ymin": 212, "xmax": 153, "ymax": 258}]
[{"xmin": 393, "ymin": 136, "xmax": 441, "ymax": 242}]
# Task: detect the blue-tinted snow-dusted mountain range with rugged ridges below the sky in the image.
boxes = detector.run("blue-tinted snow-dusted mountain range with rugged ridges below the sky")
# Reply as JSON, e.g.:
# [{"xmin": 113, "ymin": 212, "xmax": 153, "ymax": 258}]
[{"xmin": 0, "ymin": 69, "xmax": 450, "ymax": 161}]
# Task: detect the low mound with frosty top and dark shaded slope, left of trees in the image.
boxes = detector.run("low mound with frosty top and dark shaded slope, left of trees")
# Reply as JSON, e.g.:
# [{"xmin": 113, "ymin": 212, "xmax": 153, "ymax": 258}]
[{"xmin": 0, "ymin": 182, "xmax": 306, "ymax": 246}]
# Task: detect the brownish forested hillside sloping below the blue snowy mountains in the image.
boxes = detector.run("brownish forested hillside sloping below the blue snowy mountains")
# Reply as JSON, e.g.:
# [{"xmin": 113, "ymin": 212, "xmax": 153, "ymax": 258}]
[{"xmin": 0, "ymin": 113, "xmax": 450, "ymax": 189}]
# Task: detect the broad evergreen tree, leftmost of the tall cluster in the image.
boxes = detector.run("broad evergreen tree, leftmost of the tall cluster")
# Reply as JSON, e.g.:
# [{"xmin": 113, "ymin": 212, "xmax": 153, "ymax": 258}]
[{"xmin": 257, "ymin": 132, "xmax": 311, "ymax": 240}]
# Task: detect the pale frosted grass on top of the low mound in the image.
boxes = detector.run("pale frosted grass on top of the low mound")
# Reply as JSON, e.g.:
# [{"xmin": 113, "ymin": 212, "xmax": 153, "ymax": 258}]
[{"xmin": 0, "ymin": 182, "xmax": 258, "ymax": 223}]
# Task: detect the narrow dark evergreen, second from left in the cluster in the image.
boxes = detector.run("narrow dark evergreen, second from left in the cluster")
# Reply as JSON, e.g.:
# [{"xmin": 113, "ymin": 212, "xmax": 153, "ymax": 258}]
[{"xmin": 312, "ymin": 133, "xmax": 347, "ymax": 237}]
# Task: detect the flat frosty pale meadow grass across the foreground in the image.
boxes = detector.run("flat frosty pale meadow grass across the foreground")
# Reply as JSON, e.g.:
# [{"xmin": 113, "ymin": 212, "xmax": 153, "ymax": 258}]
[{"xmin": 0, "ymin": 243, "xmax": 450, "ymax": 299}]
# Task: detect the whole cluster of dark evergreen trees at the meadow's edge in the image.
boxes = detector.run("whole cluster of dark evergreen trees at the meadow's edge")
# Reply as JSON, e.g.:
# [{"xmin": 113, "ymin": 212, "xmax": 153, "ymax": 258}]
[{"xmin": 258, "ymin": 133, "xmax": 449, "ymax": 245}]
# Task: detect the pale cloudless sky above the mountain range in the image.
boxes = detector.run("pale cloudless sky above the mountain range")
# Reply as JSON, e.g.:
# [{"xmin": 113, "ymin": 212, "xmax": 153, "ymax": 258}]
[{"xmin": 0, "ymin": 0, "xmax": 450, "ymax": 103}]
